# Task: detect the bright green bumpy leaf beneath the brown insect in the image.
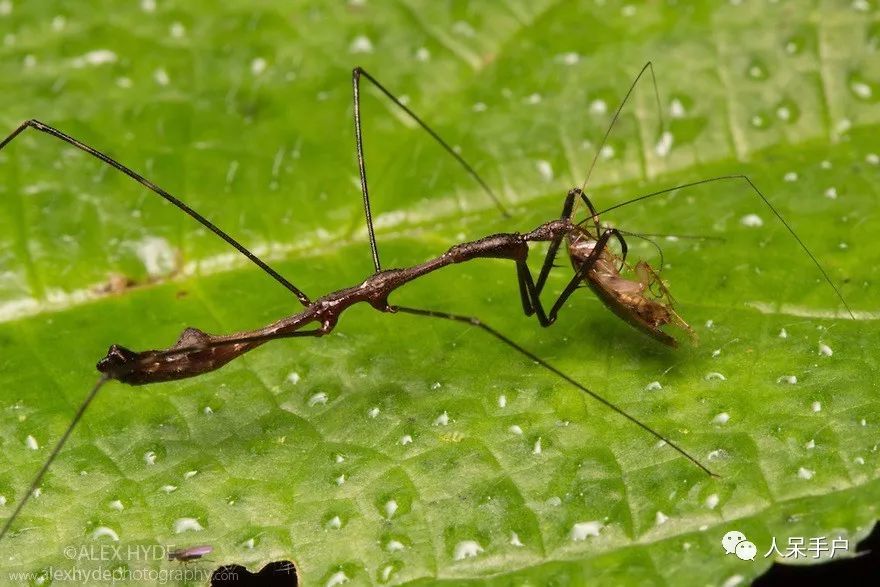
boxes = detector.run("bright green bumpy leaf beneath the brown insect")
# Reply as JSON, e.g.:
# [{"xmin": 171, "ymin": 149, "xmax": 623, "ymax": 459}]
[{"xmin": 0, "ymin": 0, "xmax": 880, "ymax": 585}]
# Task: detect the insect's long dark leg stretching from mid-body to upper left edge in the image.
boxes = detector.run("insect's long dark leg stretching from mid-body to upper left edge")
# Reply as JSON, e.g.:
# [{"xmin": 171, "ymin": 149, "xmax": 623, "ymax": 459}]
[{"xmin": 0, "ymin": 119, "xmax": 311, "ymax": 306}]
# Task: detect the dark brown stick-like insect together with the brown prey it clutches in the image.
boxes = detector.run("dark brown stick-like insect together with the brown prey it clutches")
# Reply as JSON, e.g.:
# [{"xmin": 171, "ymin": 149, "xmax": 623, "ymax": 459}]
[{"xmin": 0, "ymin": 62, "xmax": 852, "ymax": 539}]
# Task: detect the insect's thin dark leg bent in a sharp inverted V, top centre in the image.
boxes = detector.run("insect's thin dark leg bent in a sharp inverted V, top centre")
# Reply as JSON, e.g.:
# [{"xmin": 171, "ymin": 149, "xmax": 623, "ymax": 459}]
[{"xmin": 351, "ymin": 67, "xmax": 510, "ymax": 271}]
